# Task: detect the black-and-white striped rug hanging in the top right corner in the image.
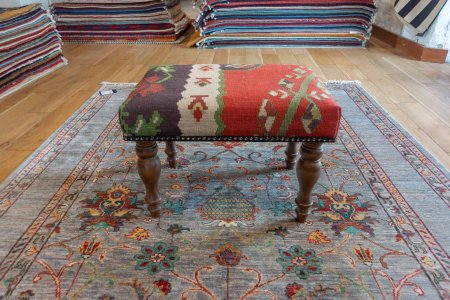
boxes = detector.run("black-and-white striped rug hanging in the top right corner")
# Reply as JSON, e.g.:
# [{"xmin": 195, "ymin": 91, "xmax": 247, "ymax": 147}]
[{"xmin": 395, "ymin": 0, "xmax": 447, "ymax": 34}]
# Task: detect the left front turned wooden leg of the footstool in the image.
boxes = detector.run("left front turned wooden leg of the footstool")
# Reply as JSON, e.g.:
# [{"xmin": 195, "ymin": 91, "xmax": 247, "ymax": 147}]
[{"xmin": 136, "ymin": 142, "xmax": 161, "ymax": 218}]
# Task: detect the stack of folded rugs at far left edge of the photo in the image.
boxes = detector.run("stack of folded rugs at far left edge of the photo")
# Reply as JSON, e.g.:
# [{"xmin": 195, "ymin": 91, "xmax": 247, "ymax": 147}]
[{"xmin": 0, "ymin": 5, "xmax": 66, "ymax": 98}]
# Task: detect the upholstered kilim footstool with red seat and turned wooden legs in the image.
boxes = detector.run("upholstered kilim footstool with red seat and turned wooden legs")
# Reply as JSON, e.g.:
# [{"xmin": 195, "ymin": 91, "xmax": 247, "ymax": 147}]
[{"xmin": 119, "ymin": 65, "xmax": 341, "ymax": 222}]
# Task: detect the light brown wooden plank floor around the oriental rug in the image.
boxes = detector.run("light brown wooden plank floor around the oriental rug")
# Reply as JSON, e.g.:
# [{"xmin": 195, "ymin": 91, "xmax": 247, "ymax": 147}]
[{"xmin": 0, "ymin": 40, "xmax": 450, "ymax": 181}]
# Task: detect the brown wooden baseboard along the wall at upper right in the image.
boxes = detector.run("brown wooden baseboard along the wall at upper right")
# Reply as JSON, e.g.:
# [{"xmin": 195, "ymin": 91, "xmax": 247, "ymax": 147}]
[{"xmin": 372, "ymin": 25, "xmax": 448, "ymax": 64}]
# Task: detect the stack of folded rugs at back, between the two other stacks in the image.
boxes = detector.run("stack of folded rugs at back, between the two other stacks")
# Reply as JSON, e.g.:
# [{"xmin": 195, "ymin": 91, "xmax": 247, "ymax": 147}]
[{"xmin": 52, "ymin": 0, "xmax": 189, "ymax": 43}]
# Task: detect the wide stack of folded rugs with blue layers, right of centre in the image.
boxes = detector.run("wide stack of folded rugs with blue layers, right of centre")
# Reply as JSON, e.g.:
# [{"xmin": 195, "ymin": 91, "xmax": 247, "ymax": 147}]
[{"xmin": 194, "ymin": 0, "xmax": 376, "ymax": 48}]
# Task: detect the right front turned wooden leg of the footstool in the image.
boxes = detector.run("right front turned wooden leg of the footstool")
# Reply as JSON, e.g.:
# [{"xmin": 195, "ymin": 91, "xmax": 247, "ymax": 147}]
[{"xmin": 295, "ymin": 143, "xmax": 322, "ymax": 223}]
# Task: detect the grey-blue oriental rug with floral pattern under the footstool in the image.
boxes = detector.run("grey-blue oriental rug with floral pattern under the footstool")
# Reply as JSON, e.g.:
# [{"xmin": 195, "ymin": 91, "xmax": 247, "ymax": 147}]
[{"xmin": 0, "ymin": 82, "xmax": 450, "ymax": 300}]
